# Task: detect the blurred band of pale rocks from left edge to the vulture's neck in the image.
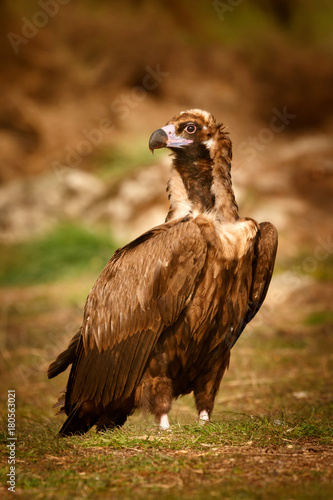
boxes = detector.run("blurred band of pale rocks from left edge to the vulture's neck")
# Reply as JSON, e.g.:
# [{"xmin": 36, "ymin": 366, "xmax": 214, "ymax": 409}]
[{"xmin": 0, "ymin": 161, "xmax": 169, "ymax": 243}]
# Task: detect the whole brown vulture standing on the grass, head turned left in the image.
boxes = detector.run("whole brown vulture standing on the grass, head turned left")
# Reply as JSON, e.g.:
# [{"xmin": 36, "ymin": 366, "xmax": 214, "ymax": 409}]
[{"xmin": 48, "ymin": 109, "xmax": 277, "ymax": 436}]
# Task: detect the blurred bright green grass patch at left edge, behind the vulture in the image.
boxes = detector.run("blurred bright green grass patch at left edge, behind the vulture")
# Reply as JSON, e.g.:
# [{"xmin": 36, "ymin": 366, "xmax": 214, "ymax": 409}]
[{"xmin": 0, "ymin": 224, "xmax": 117, "ymax": 286}]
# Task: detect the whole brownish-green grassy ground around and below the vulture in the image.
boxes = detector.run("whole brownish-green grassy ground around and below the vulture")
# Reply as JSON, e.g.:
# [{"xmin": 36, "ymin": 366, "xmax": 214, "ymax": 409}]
[{"xmin": 0, "ymin": 229, "xmax": 333, "ymax": 500}]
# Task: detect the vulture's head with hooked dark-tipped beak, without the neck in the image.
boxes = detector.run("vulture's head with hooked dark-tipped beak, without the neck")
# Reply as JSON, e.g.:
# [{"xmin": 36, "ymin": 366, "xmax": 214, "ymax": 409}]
[{"xmin": 149, "ymin": 109, "xmax": 231, "ymax": 161}]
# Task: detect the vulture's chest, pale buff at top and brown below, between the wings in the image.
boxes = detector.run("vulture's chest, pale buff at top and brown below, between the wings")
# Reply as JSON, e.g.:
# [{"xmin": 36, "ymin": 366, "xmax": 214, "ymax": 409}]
[{"xmin": 180, "ymin": 218, "xmax": 258, "ymax": 347}]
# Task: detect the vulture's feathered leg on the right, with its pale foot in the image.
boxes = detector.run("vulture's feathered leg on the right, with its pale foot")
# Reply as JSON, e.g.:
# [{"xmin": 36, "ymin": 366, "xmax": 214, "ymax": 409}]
[{"xmin": 193, "ymin": 352, "xmax": 230, "ymax": 423}]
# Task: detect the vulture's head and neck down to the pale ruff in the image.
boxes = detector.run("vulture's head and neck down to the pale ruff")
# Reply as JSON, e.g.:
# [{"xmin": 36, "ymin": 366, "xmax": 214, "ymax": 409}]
[{"xmin": 149, "ymin": 109, "xmax": 238, "ymax": 220}]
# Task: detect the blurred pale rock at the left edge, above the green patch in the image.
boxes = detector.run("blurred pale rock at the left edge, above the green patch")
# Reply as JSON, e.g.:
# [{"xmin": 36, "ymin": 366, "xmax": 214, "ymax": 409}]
[{"xmin": 0, "ymin": 170, "xmax": 105, "ymax": 243}]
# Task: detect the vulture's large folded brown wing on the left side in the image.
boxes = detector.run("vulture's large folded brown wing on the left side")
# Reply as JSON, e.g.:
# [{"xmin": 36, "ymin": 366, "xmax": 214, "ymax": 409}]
[{"xmin": 65, "ymin": 219, "xmax": 207, "ymax": 414}]
